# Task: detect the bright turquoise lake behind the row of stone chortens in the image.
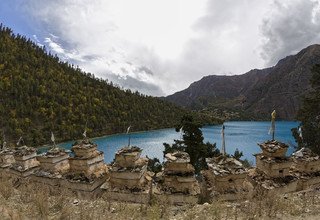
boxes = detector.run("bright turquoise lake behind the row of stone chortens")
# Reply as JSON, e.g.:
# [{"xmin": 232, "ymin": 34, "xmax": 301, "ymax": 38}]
[{"xmin": 59, "ymin": 121, "xmax": 299, "ymax": 163}]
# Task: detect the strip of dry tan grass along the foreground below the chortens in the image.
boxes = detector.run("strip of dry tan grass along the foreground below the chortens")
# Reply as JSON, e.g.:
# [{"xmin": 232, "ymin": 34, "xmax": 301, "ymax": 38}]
[{"xmin": 0, "ymin": 175, "xmax": 320, "ymax": 220}]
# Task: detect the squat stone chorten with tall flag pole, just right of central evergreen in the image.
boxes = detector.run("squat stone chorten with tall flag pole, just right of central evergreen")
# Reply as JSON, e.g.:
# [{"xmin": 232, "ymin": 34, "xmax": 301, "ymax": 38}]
[{"xmin": 202, "ymin": 155, "xmax": 249, "ymax": 200}]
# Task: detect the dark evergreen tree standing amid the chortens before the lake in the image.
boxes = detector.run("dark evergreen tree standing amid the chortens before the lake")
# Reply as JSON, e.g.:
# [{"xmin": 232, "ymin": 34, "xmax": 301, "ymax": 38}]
[{"xmin": 164, "ymin": 115, "xmax": 220, "ymax": 174}]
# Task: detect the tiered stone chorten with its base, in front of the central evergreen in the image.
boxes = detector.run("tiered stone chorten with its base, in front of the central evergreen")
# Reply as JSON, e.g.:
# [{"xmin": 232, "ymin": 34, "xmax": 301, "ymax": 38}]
[{"xmin": 154, "ymin": 151, "xmax": 200, "ymax": 203}]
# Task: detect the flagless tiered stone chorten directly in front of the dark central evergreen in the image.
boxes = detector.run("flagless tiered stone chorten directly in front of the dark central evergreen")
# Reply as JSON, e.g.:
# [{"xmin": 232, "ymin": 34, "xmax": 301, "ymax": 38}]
[{"xmin": 161, "ymin": 151, "xmax": 200, "ymax": 195}]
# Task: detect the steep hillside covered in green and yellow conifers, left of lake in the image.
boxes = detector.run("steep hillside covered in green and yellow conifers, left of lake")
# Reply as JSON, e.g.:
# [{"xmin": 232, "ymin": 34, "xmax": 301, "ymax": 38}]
[{"xmin": 0, "ymin": 25, "xmax": 220, "ymax": 146}]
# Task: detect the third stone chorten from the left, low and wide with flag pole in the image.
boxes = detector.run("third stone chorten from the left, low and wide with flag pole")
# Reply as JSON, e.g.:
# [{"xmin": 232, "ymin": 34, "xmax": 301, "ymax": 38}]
[{"xmin": 35, "ymin": 146, "xmax": 70, "ymax": 185}]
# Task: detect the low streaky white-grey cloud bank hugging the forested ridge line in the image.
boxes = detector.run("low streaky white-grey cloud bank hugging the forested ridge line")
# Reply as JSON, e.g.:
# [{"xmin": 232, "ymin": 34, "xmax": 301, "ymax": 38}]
[{"xmin": 44, "ymin": 37, "xmax": 164, "ymax": 96}]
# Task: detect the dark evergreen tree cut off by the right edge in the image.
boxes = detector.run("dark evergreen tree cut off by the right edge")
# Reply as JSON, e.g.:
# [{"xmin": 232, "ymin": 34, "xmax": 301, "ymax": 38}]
[{"xmin": 293, "ymin": 64, "xmax": 320, "ymax": 155}]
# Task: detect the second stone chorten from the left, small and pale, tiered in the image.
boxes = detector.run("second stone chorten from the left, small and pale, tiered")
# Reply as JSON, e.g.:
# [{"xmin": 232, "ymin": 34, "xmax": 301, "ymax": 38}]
[{"xmin": 10, "ymin": 145, "xmax": 39, "ymax": 177}]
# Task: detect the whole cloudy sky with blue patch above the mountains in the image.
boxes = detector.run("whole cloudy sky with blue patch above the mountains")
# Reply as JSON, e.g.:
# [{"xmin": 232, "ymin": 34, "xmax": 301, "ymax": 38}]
[{"xmin": 0, "ymin": 0, "xmax": 320, "ymax": 96}]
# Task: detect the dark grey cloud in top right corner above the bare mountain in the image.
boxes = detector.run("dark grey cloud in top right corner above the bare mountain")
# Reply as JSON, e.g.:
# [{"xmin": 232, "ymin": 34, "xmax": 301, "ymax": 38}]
[{"xmin": 260, "ymin": 0, "xmax": 320, "ymax": 65}]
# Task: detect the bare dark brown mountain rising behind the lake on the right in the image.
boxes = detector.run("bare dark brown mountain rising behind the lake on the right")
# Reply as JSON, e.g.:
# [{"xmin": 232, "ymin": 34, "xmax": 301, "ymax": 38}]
[{"xmin": 165, "ymin": 45, "xmax": 320, "ymax": 120}]
